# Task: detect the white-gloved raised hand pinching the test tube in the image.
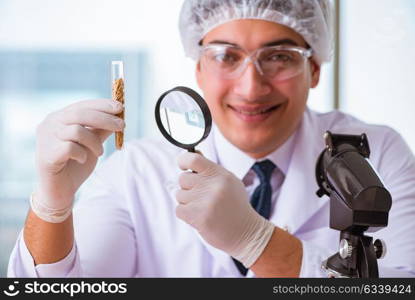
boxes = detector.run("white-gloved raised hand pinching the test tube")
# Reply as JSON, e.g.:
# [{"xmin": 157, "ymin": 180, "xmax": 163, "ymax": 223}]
[{"xmin": 31, "ymin": 99, "xmax": 125, "ymax": 223}]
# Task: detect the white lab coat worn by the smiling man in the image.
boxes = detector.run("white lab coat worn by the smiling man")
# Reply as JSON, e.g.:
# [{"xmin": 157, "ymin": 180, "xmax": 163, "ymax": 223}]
[{"xmin": 8, "ymin": 109, "xmax": 415, "ymax": 277}]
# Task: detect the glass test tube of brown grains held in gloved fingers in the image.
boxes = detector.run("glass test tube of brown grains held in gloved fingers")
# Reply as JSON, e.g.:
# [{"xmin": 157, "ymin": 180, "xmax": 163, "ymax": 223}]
[{"xmin": 111, "ymin": 61, "xmax": 124, "ymax": 150}]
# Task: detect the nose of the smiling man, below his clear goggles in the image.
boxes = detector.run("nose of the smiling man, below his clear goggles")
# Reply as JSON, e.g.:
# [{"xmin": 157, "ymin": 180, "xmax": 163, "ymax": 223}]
[{"xmin": 234, "ymin": 62, "xmax": 272, "ymax": 101}]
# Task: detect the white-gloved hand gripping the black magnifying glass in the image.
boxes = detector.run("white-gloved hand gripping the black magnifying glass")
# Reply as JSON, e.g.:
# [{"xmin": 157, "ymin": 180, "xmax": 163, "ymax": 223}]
[{"xmin": 176, "ymin": 152, "xmax": 274, "ymax": 268}]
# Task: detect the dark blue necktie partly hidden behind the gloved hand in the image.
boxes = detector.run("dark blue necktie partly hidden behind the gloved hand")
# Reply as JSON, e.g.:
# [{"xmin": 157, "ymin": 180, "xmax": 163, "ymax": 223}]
[{"xmin": 232, "ymin": 159, "xmax": 275, "ymax": 276}]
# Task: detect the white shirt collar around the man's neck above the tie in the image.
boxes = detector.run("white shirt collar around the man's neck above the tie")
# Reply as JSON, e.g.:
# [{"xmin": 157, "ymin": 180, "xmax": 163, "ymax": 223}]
[{"xmin": 212, "ymin": 125, "xmax": 297, "ymax": 180}]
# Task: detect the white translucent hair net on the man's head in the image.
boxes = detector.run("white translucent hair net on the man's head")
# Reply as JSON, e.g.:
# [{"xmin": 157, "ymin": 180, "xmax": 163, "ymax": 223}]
[{"xmin": 179, "ymin": 0, "xmax": 333, "ymax": 63}]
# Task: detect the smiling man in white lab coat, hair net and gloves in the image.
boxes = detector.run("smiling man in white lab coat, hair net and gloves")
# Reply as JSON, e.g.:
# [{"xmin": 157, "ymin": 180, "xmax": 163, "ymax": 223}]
[{"xmin": 9, "ymin": 0, "xmax": 415, "ymax": 277}]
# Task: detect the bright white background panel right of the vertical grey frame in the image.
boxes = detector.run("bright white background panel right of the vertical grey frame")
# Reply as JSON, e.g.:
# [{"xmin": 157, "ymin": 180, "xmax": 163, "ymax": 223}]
[{"xmin": 340, "ymin": 0, "xmax": 415, "ymax": 150}]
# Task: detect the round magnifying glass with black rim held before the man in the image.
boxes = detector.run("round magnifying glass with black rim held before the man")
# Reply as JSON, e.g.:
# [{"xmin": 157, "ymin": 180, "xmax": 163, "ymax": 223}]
[{"xmin": 155, "ymin": 86, "xmax": 212, "ymax": 152}]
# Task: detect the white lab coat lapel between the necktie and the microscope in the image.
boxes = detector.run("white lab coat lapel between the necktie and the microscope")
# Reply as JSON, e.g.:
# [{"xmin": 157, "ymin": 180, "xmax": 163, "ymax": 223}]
[{"xmin": 270, "ymin": 109, "xmax": 328, "ymax": 234}]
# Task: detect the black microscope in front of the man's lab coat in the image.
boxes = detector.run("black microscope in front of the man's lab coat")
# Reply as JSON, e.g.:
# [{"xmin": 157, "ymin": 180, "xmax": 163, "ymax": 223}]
[{"xmin": 316, "ymin": 131, "xmax": 392, "ymax": 278}]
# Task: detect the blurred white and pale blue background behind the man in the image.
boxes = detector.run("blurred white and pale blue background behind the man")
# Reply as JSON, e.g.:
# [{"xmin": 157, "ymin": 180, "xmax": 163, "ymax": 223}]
[{"xmin": 0, "ymin": 0, "xmax": 415, "ymax": 277}]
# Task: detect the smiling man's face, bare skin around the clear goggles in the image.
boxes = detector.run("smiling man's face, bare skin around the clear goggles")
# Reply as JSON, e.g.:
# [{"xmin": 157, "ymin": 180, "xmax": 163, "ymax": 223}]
[{"xmin": 196, "ymin": 20, "xmax": 320, "ymax": 158}]
